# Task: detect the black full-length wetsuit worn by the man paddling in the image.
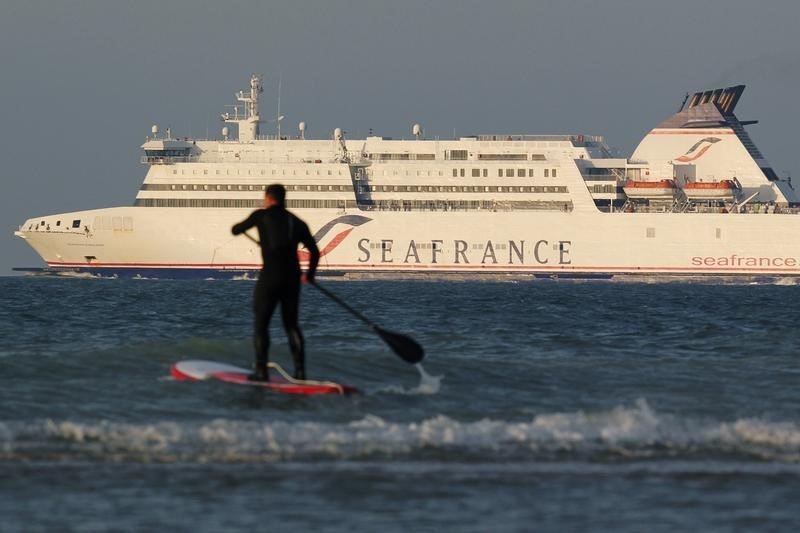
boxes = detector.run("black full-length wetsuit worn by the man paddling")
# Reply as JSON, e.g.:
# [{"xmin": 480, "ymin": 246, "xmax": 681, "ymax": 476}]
[{"xmin": 232, "ymin": 205, "xmax": 319, "ymax": 379}]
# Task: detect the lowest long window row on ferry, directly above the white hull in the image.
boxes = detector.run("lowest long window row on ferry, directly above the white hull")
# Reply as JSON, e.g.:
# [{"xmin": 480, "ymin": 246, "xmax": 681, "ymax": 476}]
[{"xmin": 134, "ymin": 198, "xmax": 572, "ymax": 211}]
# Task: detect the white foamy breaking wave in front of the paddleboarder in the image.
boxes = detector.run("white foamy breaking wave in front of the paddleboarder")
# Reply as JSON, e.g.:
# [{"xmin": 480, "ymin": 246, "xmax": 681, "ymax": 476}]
[{"xmin": 0, "ymin": 400, "xmax": 800, "ymax": 464}]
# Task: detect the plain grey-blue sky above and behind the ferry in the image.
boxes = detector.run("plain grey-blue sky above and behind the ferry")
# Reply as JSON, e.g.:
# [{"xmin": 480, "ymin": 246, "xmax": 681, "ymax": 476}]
[{"xmin": 0, "ymin": 0, "xmax": 800, "ymax": 275}]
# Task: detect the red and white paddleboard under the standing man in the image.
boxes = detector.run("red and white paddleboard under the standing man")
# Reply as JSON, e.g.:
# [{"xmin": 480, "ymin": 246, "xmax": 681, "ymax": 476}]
[{"xmin": 170, "ymin": 360, "xmax": 358, "ymax": 394}]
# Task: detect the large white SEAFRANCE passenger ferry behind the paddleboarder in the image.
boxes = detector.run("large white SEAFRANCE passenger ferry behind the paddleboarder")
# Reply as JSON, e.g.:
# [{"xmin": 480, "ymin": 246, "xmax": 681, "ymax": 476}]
[{"xmin": 15, "ymin": 75, "xmax": 800, "ymax": 278}]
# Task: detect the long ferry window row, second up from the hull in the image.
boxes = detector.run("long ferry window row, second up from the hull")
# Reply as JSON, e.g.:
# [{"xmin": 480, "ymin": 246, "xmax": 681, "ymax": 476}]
[{"xmin": 141, "ymin": 183, "xmax": 568, "ymax": 193}]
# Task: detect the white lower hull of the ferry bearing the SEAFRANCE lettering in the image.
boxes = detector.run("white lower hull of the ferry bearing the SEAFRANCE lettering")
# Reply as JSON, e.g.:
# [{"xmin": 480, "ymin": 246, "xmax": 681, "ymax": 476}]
[{"xmin": 17, "ymin": 207, "xmax": 800, "ymax": 277}]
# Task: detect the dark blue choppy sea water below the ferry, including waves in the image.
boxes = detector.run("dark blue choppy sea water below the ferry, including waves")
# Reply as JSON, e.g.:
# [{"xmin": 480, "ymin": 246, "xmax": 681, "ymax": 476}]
[{"xmin": 0, "ymin": 278, "xmax": 800, "ymax": 532}]
